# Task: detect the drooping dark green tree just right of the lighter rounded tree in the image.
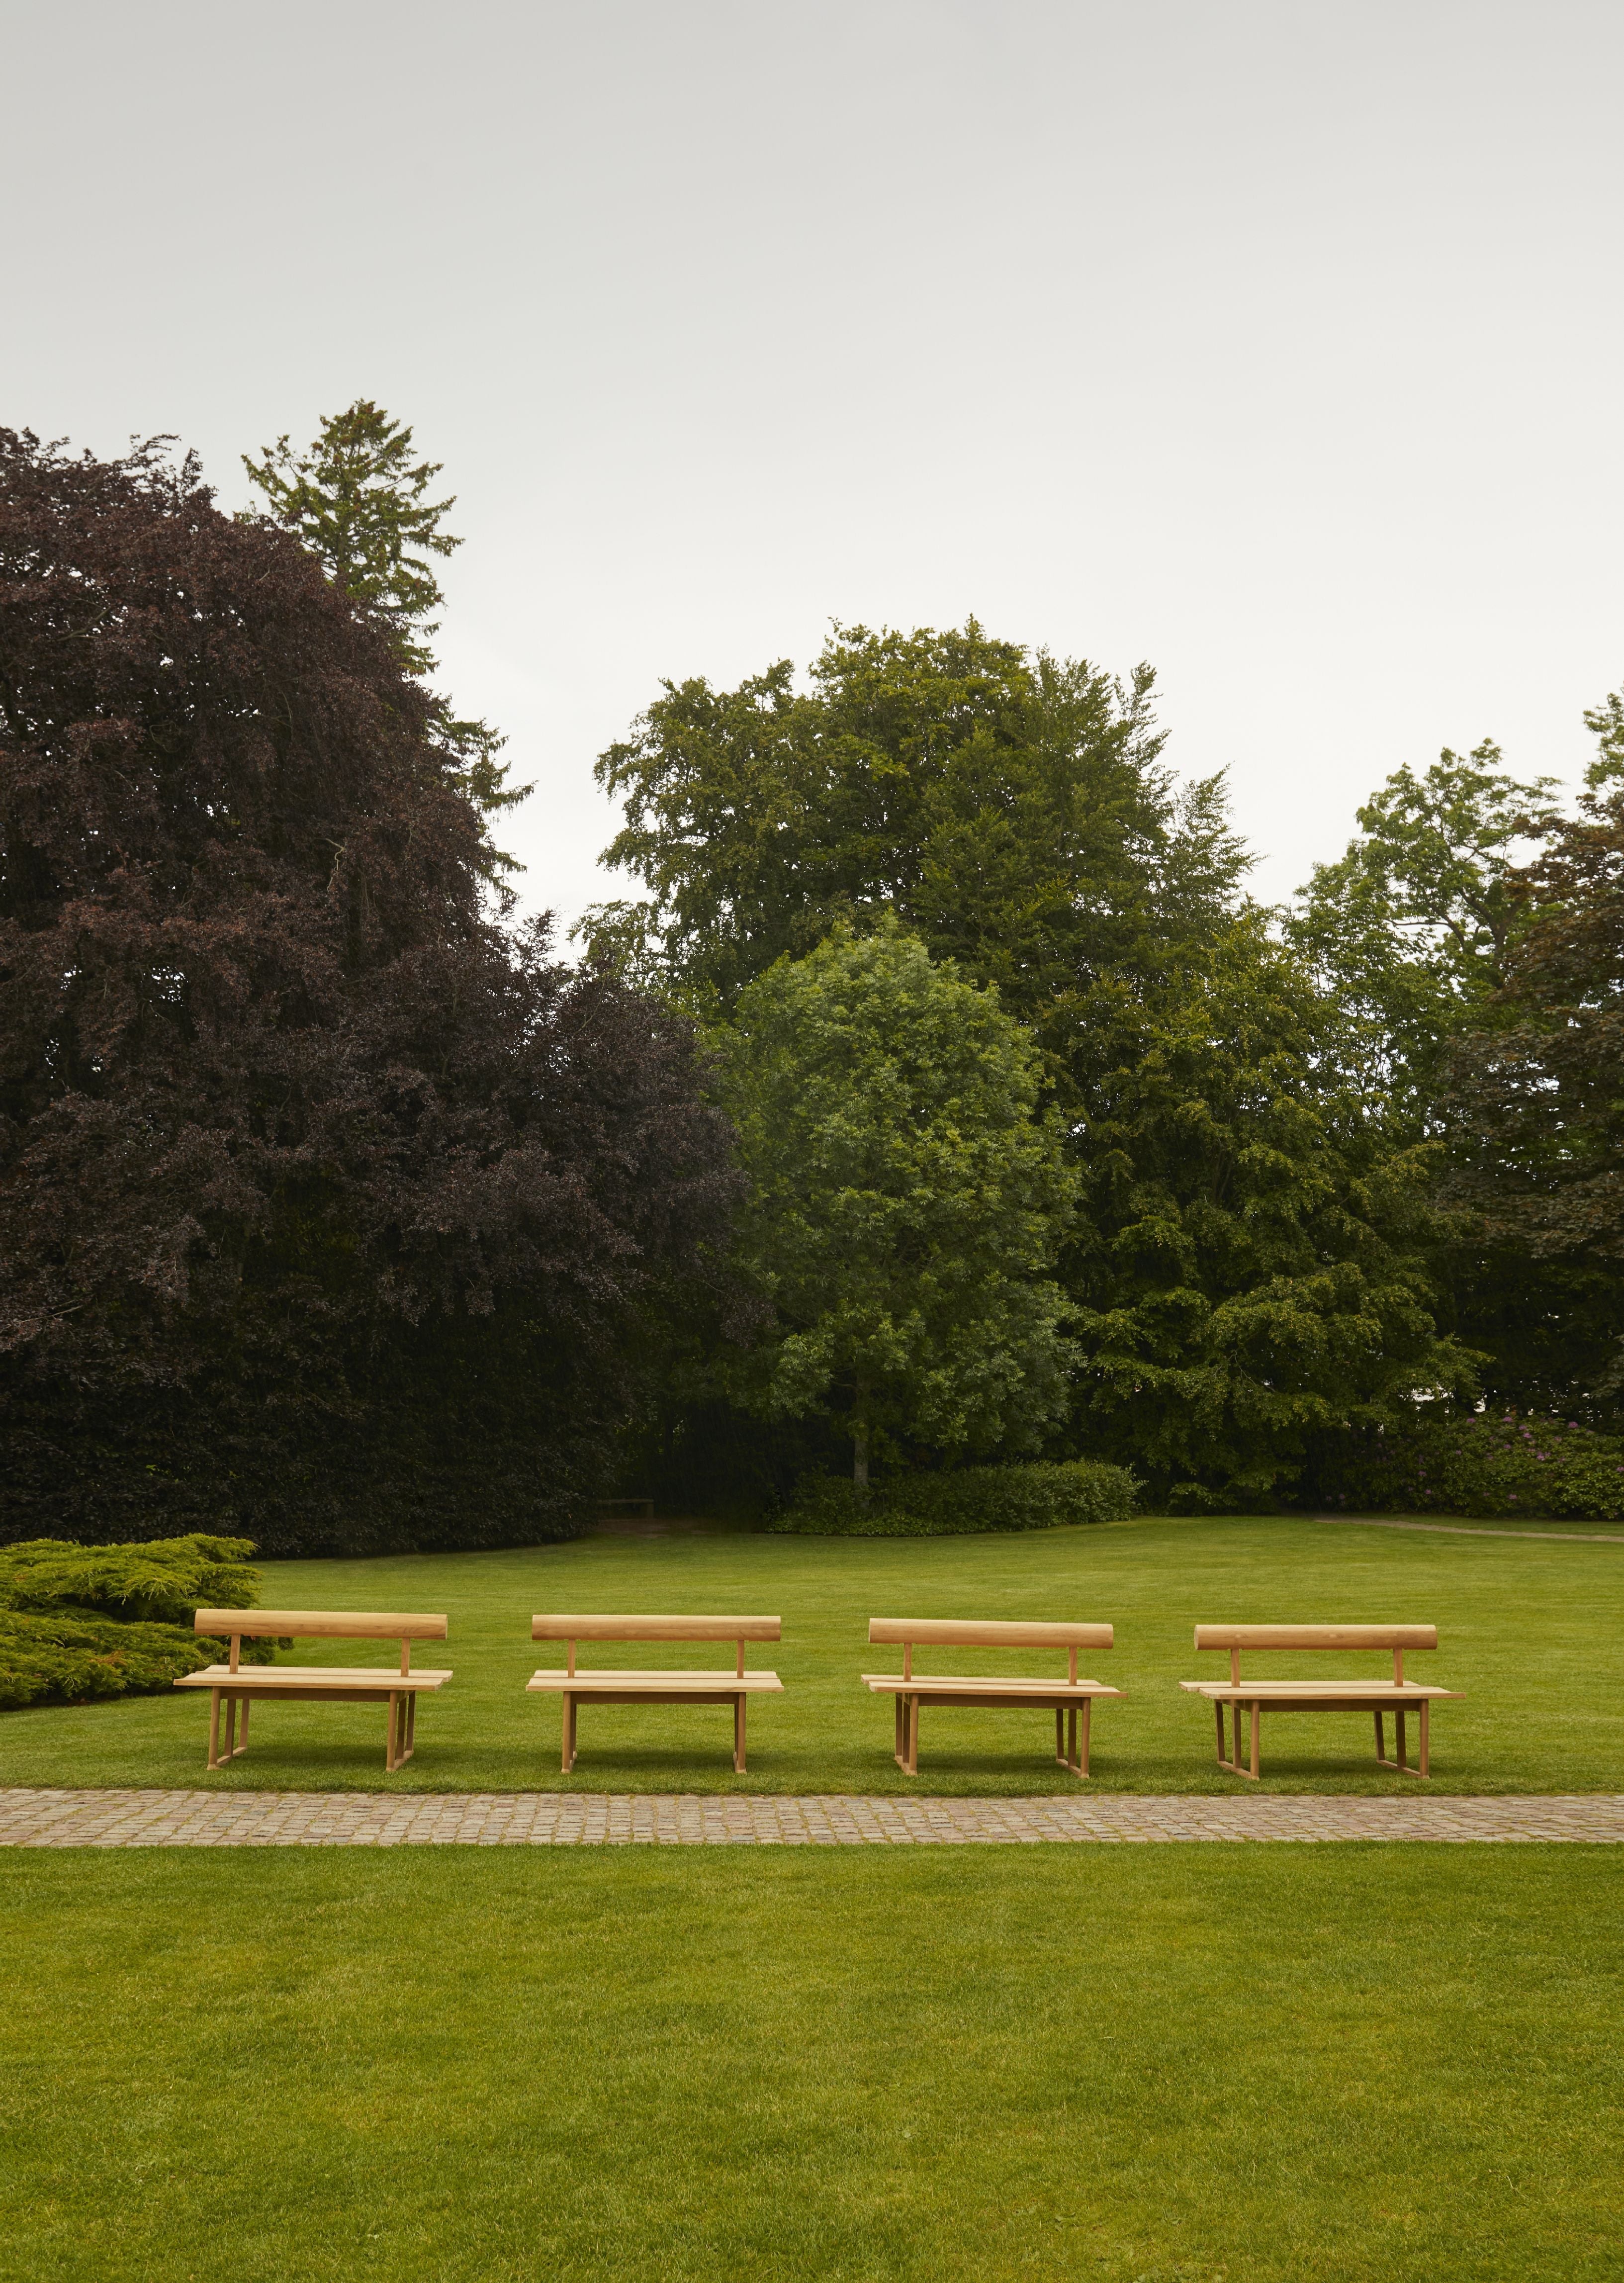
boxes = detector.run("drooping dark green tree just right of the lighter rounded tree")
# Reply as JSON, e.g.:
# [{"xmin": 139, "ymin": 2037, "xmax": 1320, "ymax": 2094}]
[{"xmin": 1067, "ymin": 913, "xmax": 1473, "ymax": 1507}]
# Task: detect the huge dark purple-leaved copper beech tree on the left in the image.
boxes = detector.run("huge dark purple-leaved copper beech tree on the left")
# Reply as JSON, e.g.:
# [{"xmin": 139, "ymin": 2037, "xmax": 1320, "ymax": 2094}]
[{"xmin": 0, "ymin": 432, "xmax": 735, "ymax": 1550}]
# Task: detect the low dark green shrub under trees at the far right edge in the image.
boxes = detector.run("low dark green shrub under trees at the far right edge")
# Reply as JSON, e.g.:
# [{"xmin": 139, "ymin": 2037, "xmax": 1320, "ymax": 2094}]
[{"xmin": 1320, "ymin": 1411, "xmax": 1624, "ymax": 1523}]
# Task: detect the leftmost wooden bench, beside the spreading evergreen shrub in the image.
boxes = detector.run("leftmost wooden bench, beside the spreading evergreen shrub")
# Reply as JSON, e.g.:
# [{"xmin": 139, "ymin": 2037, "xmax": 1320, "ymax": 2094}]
[{"xmin": 176, "ymin": 1610, "xmax": 450, "ymax": 1776}]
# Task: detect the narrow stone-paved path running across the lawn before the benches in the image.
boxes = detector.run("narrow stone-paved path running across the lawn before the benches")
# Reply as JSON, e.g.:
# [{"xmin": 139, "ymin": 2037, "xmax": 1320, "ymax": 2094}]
[{"xmin": 0, "ymin": 1790, "xmax": 1624, "ymax": 1847}]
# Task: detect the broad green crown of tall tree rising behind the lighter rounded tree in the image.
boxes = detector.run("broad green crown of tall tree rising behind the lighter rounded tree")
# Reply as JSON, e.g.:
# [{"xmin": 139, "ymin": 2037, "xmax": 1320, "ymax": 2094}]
[{"xmin": 592, "ymin": 621, "xmax": 1245, "ymax": 1073}]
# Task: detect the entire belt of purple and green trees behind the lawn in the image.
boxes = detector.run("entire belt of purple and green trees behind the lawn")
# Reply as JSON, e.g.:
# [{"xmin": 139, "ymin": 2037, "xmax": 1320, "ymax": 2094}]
[{"xmin": 0, "ymin": 399, "xmax": 1624, "ymax": 1543}]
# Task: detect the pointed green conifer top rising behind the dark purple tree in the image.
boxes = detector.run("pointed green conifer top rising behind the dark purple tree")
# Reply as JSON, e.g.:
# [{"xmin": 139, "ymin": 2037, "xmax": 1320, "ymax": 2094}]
[{"xmin": 242, "ymin": 397, "xmax": 518, "ymax": 808}]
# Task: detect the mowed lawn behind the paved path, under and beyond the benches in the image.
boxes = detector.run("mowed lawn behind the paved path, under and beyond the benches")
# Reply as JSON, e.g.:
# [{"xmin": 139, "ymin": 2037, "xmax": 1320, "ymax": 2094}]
[{"xmin": 0, "ymin": 1518, "xmax": 1624, "ymax": 1795}]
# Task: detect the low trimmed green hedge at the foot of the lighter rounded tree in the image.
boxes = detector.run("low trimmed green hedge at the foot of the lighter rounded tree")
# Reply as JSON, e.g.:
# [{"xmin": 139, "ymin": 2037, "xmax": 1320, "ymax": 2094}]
[{"xmin": 767, "ymin": 1459, "xmax": 1140, "ymax": 1539}]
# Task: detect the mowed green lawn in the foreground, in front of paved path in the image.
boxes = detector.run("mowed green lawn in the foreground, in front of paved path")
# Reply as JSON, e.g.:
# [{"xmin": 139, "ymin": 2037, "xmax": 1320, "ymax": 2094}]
[{"xmin": 0, "ymin": 1845, "xmax": 1624, "ymax": 2283}]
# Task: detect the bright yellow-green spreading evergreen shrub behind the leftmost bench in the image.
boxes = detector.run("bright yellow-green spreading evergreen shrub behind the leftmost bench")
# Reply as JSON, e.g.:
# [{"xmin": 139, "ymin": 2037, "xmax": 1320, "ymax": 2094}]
[{"xmin": 0, "ymin": 1532, "xmax": 274, "ymax": 1712}]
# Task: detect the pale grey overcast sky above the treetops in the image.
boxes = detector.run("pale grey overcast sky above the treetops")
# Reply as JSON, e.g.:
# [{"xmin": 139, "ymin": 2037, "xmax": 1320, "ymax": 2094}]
[{"xmin": 0, "ymin": 0, "xmax": 1624, "ymax": 918}]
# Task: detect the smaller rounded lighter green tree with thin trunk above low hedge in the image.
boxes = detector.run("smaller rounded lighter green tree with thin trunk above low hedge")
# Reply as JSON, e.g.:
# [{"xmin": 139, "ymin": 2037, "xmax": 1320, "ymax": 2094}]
[{"xmin": 720, "ymin": 920, "xmax": 1076, "ymax": 1486}]
